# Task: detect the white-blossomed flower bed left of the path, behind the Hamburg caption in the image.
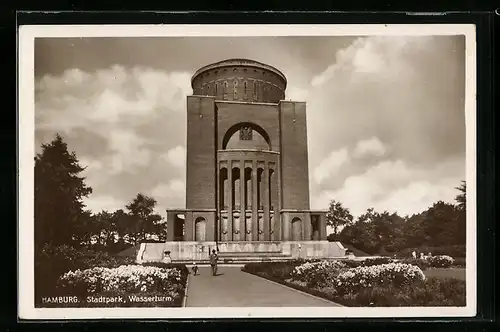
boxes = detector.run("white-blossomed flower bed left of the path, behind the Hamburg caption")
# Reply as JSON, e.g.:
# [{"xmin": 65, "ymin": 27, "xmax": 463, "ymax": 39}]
[{"xmin": 36, "ymin": 263, "xmax": 189, "ymax": 307}]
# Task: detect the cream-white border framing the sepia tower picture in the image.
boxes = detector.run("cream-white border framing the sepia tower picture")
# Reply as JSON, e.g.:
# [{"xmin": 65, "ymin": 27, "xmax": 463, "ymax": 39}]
[{"xmin": 18, "ymin": 24, "xmax": 477, "ymax": 320}]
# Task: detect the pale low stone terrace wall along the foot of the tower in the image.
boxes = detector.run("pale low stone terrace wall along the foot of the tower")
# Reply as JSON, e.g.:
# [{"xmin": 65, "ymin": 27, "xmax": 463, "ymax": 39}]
[{"xmin": 137, "ymin": 241, "xmax": 346, "ymax": 262}]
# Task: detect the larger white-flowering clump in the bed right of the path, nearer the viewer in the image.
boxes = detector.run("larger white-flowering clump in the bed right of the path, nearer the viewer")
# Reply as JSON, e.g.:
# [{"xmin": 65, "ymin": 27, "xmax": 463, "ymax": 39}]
[{"xmin": 331, "ymin": 263, "xmax": 425, "ymax": 294}]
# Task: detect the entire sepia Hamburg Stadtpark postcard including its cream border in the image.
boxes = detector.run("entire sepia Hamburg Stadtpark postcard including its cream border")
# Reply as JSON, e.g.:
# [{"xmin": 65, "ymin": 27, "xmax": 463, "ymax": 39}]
[{"xmin": 18, "ymin": 24, "xmax": 476, "ymax": 319}]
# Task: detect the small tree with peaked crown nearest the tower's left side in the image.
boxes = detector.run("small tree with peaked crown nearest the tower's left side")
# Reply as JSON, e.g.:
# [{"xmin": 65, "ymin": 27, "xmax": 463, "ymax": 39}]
[{"xmin": 126, "ymin": 193, "xmax": 163, "ymax": 245}]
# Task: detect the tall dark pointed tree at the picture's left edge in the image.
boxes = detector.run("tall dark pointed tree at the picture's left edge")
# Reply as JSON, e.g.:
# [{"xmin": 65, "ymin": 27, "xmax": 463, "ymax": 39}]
[{"xmin": 35, "ymin": 134, "xmax": 92, "ymax": 249}]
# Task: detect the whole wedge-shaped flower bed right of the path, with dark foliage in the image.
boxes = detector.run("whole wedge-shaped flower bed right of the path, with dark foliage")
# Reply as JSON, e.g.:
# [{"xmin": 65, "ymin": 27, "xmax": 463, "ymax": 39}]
[{"xmin": 242, "ymin": 260, "xmax": 465, "ymax": 306}]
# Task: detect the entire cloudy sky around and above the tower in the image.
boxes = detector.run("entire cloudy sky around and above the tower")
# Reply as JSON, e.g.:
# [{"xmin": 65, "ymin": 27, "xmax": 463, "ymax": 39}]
[{"xmin": 35, "ymin": 36, "xmax": 465, "ymax": 216}]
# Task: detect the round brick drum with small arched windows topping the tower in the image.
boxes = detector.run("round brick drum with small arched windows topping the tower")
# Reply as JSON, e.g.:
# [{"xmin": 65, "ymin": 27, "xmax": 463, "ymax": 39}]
[{"xmin": 191, "ymin": 59, "xmax": 287, "ymax": 103}]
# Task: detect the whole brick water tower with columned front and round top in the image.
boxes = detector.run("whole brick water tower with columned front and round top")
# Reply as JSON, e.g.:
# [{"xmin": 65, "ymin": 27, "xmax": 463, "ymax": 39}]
[{"xmin": 154, "ymin": 59, "xmax": 346, "ymax": 258}]
